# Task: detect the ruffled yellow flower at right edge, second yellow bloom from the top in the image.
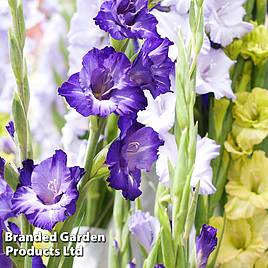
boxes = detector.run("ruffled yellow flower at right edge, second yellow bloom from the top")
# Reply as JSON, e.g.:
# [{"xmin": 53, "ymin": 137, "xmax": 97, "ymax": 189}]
[{"xmin": 232, "ymin": 88, "xmax": 268, "ymax": 151}]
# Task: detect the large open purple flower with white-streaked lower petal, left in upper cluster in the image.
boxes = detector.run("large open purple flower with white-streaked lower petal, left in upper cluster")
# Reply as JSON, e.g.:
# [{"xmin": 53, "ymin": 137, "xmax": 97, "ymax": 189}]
[{"xmin": 59, "ymin": 47, "xmax": 147, "ymax": 117}]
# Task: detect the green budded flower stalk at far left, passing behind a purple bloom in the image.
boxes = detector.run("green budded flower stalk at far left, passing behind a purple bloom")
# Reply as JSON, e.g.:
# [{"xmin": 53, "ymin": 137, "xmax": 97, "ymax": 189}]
[{"xmin": 9, "ymin": 0, "xmax": 32, "ymax": 268}]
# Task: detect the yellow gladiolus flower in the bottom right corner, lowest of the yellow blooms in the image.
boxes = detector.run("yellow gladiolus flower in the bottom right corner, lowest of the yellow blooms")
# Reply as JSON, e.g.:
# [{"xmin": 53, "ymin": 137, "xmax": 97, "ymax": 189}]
[{"xmin": 209, "ymin": 212, "xmax": 268, "ymax": 268}]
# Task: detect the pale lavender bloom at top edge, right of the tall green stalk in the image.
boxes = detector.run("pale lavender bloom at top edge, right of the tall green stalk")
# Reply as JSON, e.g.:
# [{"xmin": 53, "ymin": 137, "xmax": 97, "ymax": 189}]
[{"xmin": 204, "ymin": 0, "xmax": 253, "ymax": 47}]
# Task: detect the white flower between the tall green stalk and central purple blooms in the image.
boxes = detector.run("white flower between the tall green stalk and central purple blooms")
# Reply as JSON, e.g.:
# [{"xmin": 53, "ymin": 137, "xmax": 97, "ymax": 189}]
[{"xmin": 137, "ymin": 90, "xmax": 176, "ymax": 135}]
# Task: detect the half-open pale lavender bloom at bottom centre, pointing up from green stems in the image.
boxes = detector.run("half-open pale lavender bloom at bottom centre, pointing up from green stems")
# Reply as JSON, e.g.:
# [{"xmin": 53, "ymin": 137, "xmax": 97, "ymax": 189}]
[{"xmin": 128, "ymin": 210, "xmax": 160, "ymax": 253}]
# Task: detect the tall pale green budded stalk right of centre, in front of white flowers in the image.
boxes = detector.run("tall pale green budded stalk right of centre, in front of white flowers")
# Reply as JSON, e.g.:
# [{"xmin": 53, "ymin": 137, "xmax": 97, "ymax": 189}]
[{"xmin": 171, "ymin": 1, "xmax": 203, "ymax": 267}]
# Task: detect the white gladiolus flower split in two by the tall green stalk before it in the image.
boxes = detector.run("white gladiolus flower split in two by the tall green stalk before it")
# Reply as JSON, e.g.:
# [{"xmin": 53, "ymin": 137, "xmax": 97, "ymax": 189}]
[{"xmin": 156, "ymin": 133, "xmax": 220, "ymax": 195}]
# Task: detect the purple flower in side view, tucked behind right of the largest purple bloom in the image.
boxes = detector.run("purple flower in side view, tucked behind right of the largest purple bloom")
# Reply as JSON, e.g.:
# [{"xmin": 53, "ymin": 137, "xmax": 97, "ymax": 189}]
[{"xmin": 130, "ymin": 38, "xmax": 174, "ymax": 98}]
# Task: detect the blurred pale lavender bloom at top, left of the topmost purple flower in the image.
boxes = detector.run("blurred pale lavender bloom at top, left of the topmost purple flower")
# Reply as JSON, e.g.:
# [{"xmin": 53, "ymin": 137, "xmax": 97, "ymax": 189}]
[{"xmin": 68, "ymin": 0, "xmax": 109, "ymax": 75}]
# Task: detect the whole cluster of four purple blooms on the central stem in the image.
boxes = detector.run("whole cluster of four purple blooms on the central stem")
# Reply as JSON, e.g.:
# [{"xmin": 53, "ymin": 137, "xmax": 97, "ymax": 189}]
[{"xmin": 59, "ymin": 0, "xmax": 174, "ymax": 200}]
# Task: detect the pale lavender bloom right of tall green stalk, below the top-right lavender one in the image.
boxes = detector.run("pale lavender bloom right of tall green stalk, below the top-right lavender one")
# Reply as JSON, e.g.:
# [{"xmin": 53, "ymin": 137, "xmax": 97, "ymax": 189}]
[{"xmin": 196, "ymin": 48, "xmax": 235, "ymax": 99}]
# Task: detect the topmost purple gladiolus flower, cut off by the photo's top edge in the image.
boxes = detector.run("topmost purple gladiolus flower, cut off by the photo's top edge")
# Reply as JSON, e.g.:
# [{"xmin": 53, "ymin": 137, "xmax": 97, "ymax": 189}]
[{"xmin": 94, "ymin": 0, "xmax": 158, "ymax": 39}]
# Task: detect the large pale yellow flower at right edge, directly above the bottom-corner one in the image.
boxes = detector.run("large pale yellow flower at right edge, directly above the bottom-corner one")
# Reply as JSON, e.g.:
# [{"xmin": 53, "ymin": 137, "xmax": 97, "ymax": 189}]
[{"xmin": 225, "ymin": 151, "xmax": 268, "ymax": 220}]
